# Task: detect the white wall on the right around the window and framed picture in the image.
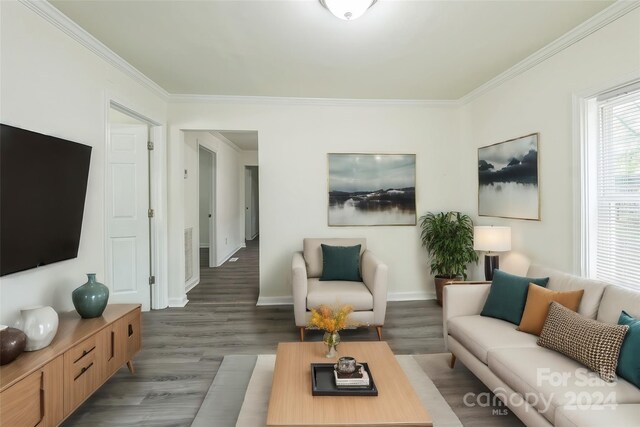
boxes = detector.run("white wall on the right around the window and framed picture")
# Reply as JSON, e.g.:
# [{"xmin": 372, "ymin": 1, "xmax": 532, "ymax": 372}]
[{"xmin": 459, "ymin": 9, "xmax": 640, "ymax": 280}]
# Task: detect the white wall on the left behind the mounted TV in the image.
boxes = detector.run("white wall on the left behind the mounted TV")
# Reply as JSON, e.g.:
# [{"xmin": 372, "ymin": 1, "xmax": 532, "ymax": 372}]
[{"xmin": 0, "ymin": 1, "xmax": 166, "ymax": 324}]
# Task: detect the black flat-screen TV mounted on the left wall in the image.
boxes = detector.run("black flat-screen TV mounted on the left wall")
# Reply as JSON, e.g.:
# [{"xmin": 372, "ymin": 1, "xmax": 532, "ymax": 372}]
[{"xmin": 0, "ymin": 124, "xmax": 91, "ymax": 276}]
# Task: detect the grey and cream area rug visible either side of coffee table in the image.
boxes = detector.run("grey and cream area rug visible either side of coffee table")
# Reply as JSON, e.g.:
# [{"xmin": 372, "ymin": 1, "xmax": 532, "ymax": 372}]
[{"xmin": 192, "ymin": 355, "xmax": 462, "ymax": 427}]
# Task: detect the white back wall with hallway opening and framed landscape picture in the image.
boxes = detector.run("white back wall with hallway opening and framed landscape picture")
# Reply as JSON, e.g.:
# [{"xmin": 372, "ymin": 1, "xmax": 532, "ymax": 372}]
[{"xmin": 169, "ymin": 102, "xmax": 466, "ymax": 299}]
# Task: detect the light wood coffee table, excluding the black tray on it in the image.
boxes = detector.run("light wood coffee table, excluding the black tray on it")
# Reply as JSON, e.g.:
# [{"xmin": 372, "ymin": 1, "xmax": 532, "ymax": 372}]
[{"xmin": 267, "ymin": 342, "xmax": 433, "ymax": 427}]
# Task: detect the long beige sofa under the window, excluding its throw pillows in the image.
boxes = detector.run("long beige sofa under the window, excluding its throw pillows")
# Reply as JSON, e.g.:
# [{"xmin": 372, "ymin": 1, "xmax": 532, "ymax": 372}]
[{"xmin": 443, "ymin": 265, "xmax": 640, "ymax": 427}]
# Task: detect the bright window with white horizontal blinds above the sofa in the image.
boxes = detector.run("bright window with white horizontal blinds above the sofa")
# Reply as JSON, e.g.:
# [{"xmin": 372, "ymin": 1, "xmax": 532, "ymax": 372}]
[{"xmin": 583, "ymin": 84, "xmax": 640, "ymax": 289}]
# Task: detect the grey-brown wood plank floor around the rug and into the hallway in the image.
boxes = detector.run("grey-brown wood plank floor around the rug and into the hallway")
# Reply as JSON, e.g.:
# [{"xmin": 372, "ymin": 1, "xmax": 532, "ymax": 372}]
[{"xmin": 64, "ymin": 242, "xmax": 512, "ymax": 427}]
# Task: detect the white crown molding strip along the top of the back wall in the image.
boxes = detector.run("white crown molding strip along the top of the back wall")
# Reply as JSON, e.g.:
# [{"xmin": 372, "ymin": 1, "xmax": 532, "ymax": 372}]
[{"xmin": 169, "ymin": 94, "xmax": 461, "ymax": 107}]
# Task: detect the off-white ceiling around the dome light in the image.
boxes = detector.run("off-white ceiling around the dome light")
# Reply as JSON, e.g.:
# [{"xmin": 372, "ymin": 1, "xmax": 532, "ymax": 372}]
[{"xmin": 51, "ymin": 0, "xmax": 613, "ymax": 100}]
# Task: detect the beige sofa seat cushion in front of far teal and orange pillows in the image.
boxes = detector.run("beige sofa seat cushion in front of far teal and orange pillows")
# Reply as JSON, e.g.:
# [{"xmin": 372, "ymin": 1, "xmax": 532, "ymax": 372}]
[{"xmin": 447, "ymin": 315, "xmax": 537, "ymax": 365}]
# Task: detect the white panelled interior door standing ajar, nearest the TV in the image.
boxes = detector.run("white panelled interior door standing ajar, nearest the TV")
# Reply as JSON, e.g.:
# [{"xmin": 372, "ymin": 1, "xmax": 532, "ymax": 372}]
[{"xmin": 105, "ymin": 124, "xmax": 151, "ymax": 310}]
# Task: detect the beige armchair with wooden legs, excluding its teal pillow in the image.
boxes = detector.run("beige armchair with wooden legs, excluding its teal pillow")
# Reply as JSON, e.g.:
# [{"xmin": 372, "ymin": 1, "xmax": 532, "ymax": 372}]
[{"xmin": 291, "ymin": 239, "xmax": 388, "ymax": 341}]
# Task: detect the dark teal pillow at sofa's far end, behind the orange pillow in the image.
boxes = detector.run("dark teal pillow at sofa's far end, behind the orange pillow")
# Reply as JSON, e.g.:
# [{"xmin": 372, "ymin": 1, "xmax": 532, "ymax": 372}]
[{"xmin": 480, "ymin": 270, "xmax": 549, "ymax": 325}]
